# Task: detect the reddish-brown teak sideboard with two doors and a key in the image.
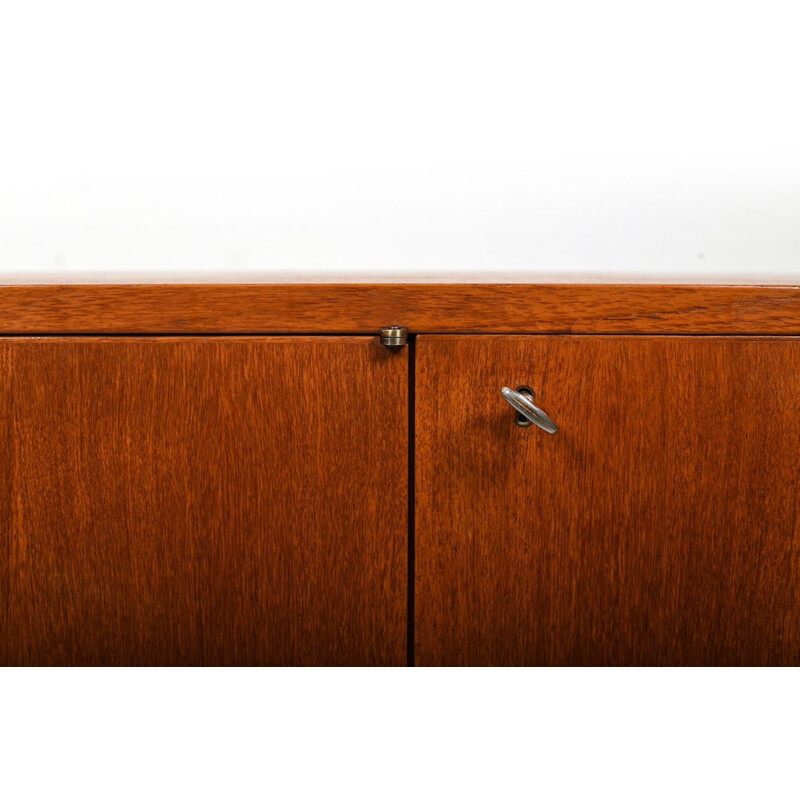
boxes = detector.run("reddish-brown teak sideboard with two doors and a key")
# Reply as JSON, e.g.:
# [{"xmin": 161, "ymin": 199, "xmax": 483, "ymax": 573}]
[{"xmin": 0, "ymin": 284, "xmax": 800, "ymax": 666}]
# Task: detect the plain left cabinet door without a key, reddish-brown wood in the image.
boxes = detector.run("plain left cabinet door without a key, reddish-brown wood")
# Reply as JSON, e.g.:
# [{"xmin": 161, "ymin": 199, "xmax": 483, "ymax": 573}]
[{"xmin": 0, "ymin": 337, "xmax": 408, "ymax": 665}]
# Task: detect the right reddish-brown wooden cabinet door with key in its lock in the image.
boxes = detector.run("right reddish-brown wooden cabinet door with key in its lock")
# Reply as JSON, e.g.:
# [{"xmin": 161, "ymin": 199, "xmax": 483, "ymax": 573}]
[{"xmin": 416, "ymin": 336, "xmax": 800, "ymax": 665}]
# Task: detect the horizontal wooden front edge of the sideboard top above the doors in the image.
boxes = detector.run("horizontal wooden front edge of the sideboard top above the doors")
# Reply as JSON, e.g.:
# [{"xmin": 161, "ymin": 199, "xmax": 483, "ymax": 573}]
[{"xmin": 0, "ymin": 284, "xmax": 800, "ymax": 335}]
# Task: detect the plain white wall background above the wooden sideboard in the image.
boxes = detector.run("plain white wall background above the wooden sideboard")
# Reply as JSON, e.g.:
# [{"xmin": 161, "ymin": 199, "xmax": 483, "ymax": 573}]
[{"xmin": 0, "ymin": 0, "xmax": 800, "ymax": 283}]
